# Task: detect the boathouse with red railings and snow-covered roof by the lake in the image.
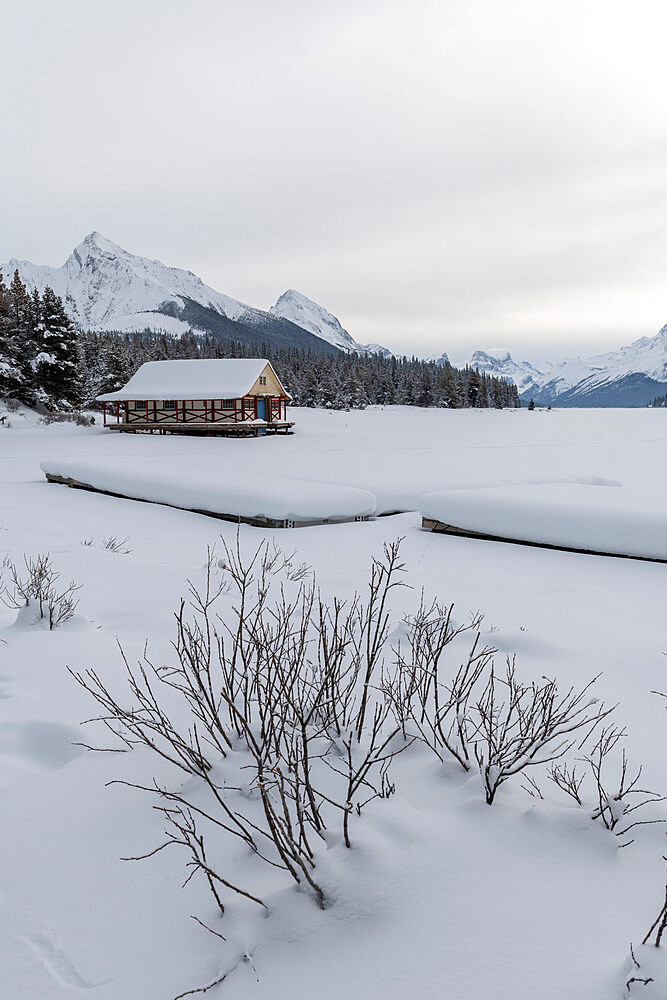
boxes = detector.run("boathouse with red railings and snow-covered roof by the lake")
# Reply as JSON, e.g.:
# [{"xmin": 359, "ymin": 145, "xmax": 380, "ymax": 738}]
[{"xmin": 97, "ymin": 358, "xmax": 294, "ymax": 437}]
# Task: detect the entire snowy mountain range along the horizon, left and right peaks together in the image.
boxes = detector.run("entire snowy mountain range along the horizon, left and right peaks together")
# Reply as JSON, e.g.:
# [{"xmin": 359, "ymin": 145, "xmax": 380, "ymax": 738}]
[{"xmin": 0, "ymin": 233, "xmax": 667, "ymax": 406}]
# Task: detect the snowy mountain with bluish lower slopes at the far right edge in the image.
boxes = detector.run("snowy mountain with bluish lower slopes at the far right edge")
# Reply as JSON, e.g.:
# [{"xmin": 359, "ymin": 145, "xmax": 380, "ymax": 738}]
[{"xmin": 468, "ymin": 326, "xmax": 667, "ymax": 406}]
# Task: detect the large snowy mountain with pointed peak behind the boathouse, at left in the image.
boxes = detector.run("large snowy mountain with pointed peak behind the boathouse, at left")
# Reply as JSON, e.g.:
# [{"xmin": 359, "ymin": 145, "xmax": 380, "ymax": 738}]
[{"xmin": 0, "ymin": 233, "xmax": 342, "ymax": 354}]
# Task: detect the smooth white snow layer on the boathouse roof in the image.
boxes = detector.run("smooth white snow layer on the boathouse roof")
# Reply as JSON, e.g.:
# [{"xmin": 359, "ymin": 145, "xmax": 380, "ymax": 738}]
[{"xmin": 97, "ymin": 358, "xmax": 287, "ymax": 402}]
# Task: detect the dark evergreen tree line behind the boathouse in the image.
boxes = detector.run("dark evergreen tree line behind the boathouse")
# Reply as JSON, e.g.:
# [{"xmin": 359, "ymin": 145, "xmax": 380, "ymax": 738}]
[{"xmin": 0, "ymin": 271, "xmax": 521, "ymax": 410}]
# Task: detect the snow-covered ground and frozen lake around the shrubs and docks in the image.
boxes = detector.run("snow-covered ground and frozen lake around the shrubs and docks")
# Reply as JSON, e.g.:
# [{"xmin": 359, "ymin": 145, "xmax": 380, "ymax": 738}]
[{"xmin": 0, "ymin": 408, "xmax": 667, "ymax": 1000}]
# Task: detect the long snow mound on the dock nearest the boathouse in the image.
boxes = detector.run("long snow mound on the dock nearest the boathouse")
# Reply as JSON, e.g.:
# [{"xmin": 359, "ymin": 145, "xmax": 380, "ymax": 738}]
[{"xmin": 40, "ymin": 458, "xmax": 376, "ymax": 521}]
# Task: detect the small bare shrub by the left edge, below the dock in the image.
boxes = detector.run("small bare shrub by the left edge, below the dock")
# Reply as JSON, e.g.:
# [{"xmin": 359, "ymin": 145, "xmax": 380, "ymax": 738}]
[{"xmin": 0, "ymin": 553, "xmax": 81, "ymax": 630}]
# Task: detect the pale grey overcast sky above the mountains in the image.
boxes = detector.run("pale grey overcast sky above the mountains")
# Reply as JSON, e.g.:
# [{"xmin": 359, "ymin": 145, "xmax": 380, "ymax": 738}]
[{"xmin": 0, "ymin": 0, "xmax": 667, "ymax": 359}]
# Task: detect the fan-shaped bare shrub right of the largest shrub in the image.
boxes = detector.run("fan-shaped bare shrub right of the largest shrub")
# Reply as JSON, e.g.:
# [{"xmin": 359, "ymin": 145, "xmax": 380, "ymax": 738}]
[{"xmin": 472, "ymin": 659, "xmax": 613, "ymax": 805}]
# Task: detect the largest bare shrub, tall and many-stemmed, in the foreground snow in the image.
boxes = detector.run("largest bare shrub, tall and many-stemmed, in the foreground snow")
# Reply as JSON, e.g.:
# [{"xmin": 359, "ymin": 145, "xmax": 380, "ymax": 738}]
[{"xmin": 74, "ymin": 538, "xmax": 409, "ymax": 912}]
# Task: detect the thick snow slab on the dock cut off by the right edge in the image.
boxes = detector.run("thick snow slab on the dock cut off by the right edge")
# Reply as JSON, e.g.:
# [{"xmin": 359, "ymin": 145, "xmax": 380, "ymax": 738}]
[{"xmin": 420, "ymin": 483, "xmax": 667, "ymax": 560}]
